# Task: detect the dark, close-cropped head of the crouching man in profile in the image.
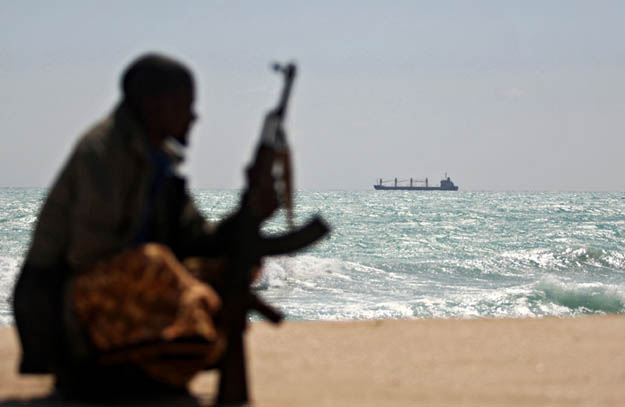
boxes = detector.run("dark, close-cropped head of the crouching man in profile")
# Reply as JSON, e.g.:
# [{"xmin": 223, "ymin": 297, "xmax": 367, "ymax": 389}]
[{"xmin": 121, "ymin": 54, "xmax": 196, "ymax": 145}]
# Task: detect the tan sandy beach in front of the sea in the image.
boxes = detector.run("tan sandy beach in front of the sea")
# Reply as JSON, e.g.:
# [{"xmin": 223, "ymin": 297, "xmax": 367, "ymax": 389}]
[{"xmin": 0, "ymin": 315, "xmax": 625, "ymax": 406}]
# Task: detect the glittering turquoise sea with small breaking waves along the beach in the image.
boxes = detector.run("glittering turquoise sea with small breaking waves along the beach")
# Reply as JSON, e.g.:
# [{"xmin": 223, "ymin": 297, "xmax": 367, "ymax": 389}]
[{"xmin": 0, "ymin": 188, "xmax": 625, "ymax": 325}]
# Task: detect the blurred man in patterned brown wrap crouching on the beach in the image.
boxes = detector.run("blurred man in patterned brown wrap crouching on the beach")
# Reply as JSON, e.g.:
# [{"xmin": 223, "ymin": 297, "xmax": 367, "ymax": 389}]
[{"xmin": 14, "ymin": 54, "xmax": 278, "ymax": 396}]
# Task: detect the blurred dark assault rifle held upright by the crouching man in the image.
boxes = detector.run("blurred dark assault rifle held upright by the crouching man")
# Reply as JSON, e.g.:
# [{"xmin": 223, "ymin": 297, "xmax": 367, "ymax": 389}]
[{"xmin": 216, "ymin": 64, "xmax": 330, "ymax": 404}]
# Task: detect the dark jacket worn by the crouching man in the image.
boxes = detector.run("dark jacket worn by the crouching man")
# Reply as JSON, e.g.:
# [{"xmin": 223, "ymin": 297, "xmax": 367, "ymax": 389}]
[{"xmin": 14, "ymin": 103, "xmax": 223, "ymax": 373}]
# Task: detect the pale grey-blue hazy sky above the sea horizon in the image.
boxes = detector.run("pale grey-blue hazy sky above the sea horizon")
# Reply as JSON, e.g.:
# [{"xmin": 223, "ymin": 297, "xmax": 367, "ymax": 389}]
[{"xmin": 0, "ymin": 0, "xmax": 625, "ymax": 191}]
